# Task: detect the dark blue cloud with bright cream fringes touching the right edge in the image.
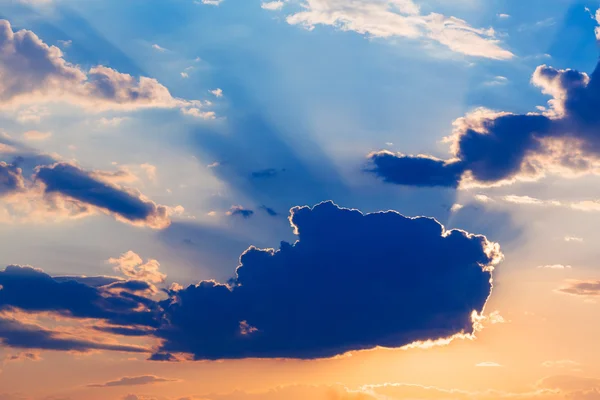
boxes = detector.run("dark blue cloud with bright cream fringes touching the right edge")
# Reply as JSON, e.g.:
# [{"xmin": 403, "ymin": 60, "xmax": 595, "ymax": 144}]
[{"xmin": 369, "ymin": 57, "xmax": 600, "ymax": 187}]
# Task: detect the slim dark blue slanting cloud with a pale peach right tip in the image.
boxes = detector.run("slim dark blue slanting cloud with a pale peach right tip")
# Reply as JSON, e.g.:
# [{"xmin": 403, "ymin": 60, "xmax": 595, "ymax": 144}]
[{"xmin": 36, "ymin": 163, "xmax": 170, "ymax": 228}]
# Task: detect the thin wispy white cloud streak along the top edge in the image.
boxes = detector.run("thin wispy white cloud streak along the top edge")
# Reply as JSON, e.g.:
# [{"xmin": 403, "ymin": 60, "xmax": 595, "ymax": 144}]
[{"xmin": 278, "ymin": 0, "xmax": 514, "ymax": 60}]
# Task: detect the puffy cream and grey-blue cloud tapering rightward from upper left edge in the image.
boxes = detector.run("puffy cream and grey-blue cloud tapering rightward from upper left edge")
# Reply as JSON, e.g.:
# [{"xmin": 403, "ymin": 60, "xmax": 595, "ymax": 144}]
[{"xmin": 0, "ymin": 20, "xmax": 213, "ymax": 116}]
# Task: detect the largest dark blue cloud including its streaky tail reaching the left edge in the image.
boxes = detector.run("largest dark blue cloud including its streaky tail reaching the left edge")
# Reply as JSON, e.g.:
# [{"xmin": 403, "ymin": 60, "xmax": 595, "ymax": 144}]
[{"xmin": 0, "ymin": 202, "xmax": 501, "ymax": 361}]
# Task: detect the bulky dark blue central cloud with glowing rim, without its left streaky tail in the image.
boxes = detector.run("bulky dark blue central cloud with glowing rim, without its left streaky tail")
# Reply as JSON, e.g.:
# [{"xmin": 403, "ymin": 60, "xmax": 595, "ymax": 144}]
[{"xmin": 157, "ymin": 202, "xmax": 501, "ymax": 359}]
